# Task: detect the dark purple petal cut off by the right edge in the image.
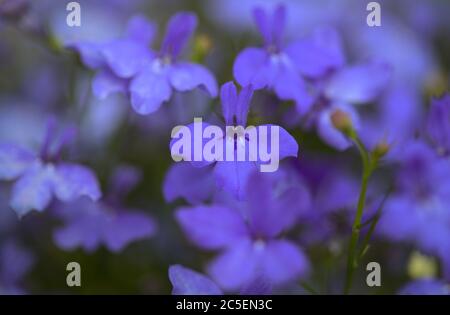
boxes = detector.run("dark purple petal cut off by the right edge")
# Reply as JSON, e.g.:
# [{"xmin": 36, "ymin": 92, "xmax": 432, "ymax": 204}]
[{"xmin": 426, "ymin": 93, "xmax": 450, "ymax": 155}]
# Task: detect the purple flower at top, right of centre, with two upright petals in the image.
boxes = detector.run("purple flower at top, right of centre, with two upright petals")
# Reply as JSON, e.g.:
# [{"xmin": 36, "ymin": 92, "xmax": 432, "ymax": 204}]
[{"xmin": 233, "ymin": 5, "xmax": 312, "ymax": 113}]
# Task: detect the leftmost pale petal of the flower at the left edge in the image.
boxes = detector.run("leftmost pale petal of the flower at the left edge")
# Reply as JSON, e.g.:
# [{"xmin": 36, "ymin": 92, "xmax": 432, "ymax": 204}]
[{"xmin": 0, "ymin": 143, "xmax": 36, "ymax": 180}]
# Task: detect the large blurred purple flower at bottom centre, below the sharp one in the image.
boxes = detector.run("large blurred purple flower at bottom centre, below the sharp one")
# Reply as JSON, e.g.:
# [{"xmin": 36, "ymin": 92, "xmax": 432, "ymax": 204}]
[{"xmin": 176, "ymin": 172, "xmax": 309, "ymax": 290}]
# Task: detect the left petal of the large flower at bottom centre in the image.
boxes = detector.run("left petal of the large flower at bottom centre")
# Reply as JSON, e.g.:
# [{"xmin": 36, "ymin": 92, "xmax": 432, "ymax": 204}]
[{"xmin": 175, "ymin": 206, "xmax": 248, "ymax": 249}]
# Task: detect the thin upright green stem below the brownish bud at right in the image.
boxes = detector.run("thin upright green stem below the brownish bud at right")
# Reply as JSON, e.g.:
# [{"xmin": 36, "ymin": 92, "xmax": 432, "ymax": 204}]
[{"xmin": 344, "ymin": 135, "xmax": 376, "ymax": 294}]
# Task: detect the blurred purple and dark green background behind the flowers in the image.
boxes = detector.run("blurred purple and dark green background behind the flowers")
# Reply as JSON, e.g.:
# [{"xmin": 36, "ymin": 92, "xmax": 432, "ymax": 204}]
[{"xmin": 0, "ymin": 0, "xmax": 450, "ymax": 294}]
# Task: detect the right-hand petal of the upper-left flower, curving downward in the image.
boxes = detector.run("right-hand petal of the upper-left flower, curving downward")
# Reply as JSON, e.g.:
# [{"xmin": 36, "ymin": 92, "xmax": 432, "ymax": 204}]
[{"xmin": 169, "ymin": 62, "xmax": 217, "ymax": 97}]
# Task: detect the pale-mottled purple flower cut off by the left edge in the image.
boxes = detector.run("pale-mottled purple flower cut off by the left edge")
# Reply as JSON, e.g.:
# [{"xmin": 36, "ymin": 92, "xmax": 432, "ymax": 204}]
[{"xmin": 0, "ymin": 119, "xmax": 101, "ymax": 216}]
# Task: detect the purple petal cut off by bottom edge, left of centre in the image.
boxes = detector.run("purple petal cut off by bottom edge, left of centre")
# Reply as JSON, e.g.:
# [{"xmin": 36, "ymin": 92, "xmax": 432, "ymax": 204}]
[{"xmin": 169, "ymin": 265, "xmax": 223, "ymax": 295}]
